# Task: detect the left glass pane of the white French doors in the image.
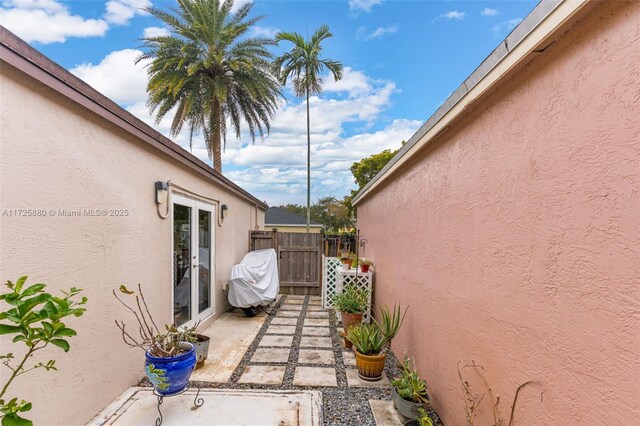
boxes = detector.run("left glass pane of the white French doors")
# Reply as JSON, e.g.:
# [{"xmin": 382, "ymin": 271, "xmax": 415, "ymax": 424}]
[{"xmin": 173, "ymin": 204, "xmax": 191, "ymax": 325}]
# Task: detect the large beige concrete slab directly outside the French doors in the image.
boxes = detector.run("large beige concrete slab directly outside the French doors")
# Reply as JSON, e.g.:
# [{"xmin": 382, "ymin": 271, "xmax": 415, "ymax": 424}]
[{"xmin": 191, "ymin": 311, "xmax": 267, "ymax": 383}]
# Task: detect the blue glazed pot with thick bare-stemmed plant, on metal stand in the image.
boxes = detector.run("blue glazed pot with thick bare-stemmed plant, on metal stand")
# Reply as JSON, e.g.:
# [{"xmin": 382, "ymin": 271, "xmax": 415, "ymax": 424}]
[{"xmin": 113, "ymin": 284, "xmax": 196, "ymax": 396}]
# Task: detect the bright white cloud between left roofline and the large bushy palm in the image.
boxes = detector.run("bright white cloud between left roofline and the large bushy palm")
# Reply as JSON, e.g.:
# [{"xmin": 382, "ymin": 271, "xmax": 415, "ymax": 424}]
[{"xmin": 70, "ymin": 49, "xmax": 147, "ymax": 105}]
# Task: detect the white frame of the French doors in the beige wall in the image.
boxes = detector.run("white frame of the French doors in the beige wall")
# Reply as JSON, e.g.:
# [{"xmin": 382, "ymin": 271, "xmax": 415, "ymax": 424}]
[{"xmin": 169, "ymin": 193, "xmax": 217, "ymax": 328}]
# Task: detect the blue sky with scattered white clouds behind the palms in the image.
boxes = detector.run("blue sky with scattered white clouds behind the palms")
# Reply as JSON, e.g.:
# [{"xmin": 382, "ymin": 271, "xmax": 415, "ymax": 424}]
[{"xmin": 0, "ymin": 0, "xmax": 537, "ymax": 205}]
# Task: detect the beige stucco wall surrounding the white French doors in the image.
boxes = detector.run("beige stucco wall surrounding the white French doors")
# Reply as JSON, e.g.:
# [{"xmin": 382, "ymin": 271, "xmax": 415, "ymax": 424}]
[{"xmin": 0, "ymin": 64, "xmax": 264, "ymax": 425}]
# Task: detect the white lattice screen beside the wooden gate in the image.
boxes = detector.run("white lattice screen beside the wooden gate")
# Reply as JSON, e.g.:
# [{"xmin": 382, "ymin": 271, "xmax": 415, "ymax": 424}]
[{"xmin": 322, "ymin": 256, "xmax": 373, "ymax": 322}]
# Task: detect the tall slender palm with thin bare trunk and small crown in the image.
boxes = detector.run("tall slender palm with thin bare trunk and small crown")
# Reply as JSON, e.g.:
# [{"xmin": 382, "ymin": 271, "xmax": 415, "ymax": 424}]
[{"xmin": 274, "ymin": 25, "xmax": 342, "ymax": 233}]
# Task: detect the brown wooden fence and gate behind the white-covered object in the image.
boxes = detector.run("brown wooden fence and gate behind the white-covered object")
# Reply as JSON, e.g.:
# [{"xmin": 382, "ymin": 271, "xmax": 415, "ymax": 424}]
[{"xmin": 249, "ymin": 231, "xmax": 323, "ymax": 295}]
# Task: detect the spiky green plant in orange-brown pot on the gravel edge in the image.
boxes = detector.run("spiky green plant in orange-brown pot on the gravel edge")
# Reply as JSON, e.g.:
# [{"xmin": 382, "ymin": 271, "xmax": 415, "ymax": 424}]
[{"xmin": 346, "ymin": 305, "xmax": 407, "ymax": 381}]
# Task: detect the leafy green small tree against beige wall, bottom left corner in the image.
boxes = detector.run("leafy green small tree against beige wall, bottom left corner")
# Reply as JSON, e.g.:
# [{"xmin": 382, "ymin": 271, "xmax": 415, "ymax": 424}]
[{"xmin": 0, "ymin": 275, "xmax": 87, "ymax": 426}]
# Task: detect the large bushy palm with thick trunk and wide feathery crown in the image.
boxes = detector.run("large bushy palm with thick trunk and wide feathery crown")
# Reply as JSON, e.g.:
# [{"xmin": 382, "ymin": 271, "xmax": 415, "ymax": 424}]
[{"xmin": 138, "ymin": 0, "xmax": 282, "ymax": 172}]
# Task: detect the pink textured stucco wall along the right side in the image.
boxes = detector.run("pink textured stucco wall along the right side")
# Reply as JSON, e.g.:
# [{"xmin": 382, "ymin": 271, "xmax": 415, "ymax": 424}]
[{"xmin": 358, "ymin": 2, "xmax": 640, "ymax": 425}]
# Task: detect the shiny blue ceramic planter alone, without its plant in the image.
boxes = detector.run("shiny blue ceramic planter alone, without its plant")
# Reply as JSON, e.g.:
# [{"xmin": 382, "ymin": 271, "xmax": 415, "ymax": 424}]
[{"xmin": 144, "ymin": 342, "xmax": 196, "ymax": 395}]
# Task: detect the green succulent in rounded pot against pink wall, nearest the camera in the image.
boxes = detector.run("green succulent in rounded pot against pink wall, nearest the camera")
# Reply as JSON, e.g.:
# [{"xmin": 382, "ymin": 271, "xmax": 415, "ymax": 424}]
[{"xmin": 391, "ymin": 355, "xmax": 429, "ymax": 419}]
